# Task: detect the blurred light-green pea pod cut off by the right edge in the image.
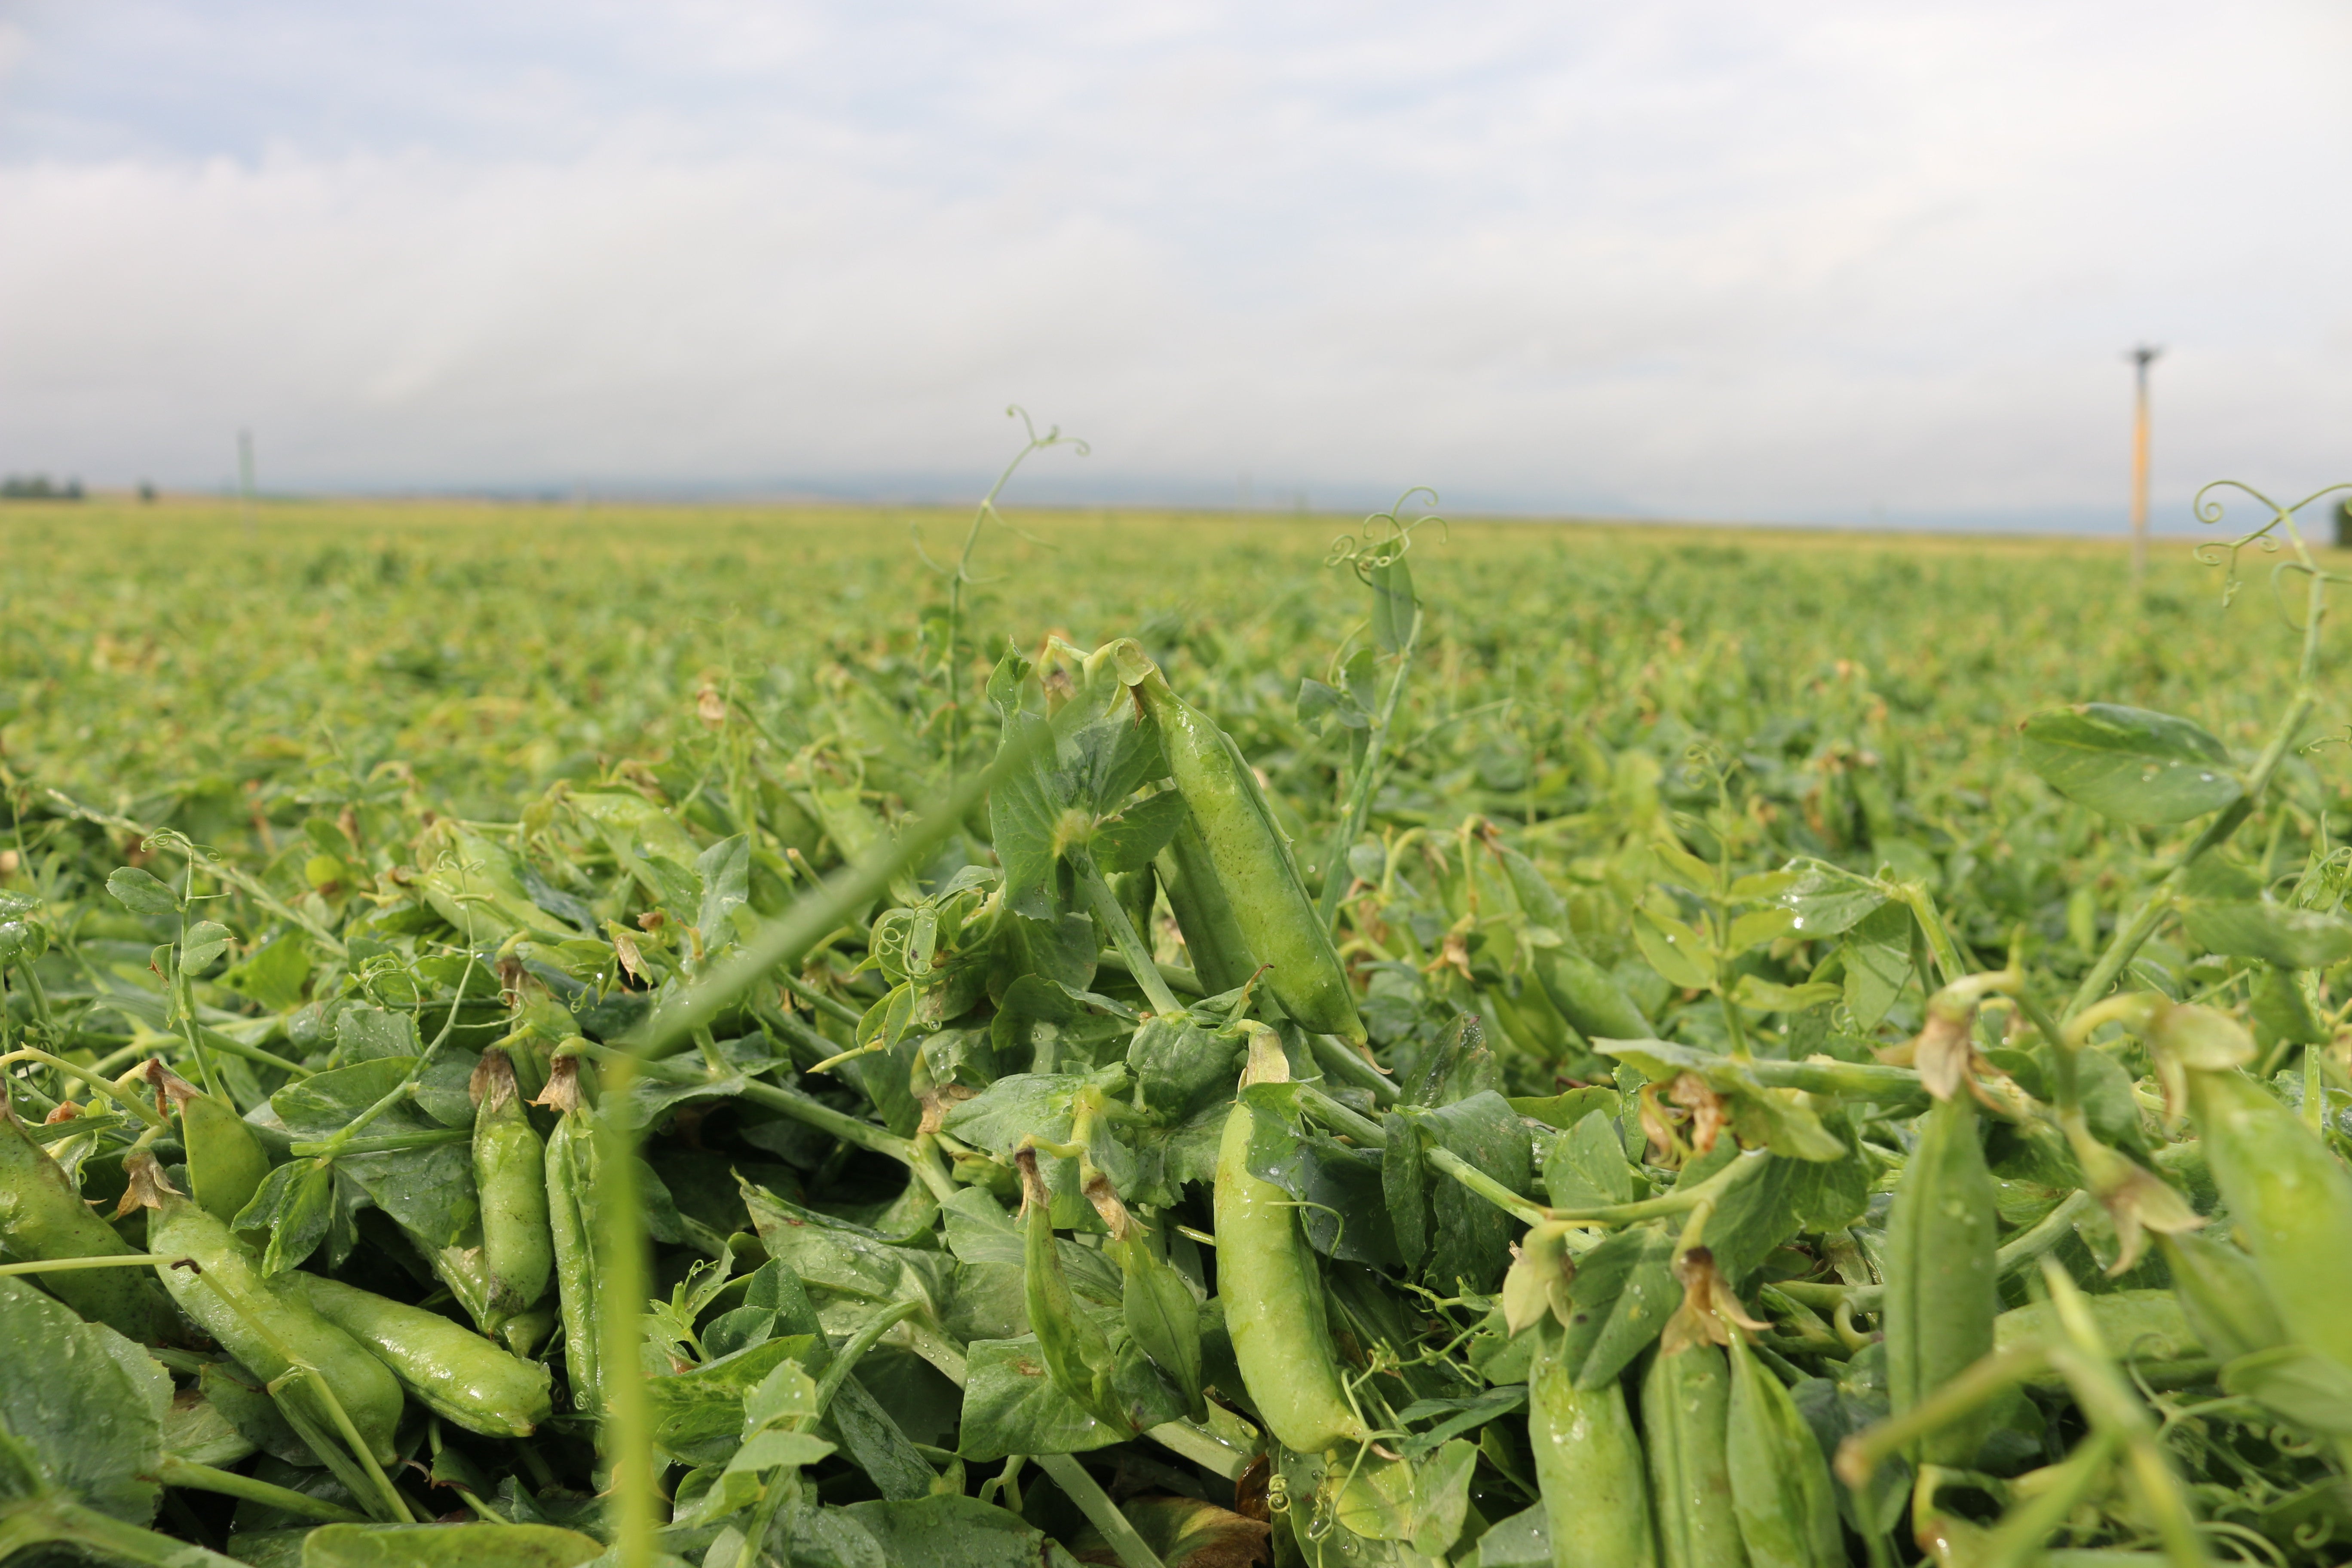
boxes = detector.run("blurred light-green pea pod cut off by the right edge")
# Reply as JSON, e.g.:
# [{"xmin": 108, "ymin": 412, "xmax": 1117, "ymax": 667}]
[{"xmin": 2187, "ymin": 1070, "xmax": 2352, "ymax": 1366}]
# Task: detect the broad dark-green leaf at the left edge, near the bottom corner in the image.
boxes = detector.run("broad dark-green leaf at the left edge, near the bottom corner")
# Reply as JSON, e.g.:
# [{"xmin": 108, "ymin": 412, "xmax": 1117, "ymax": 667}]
[{"xmin": 0, "ymin": 1279, "xmax": 172, "ymax": 1523}]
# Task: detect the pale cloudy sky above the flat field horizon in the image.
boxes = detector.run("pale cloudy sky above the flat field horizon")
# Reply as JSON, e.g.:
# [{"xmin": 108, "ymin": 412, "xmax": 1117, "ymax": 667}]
[{"xmin": 0, "ymin": 0, "xmax": 2352, "ymax": 527}]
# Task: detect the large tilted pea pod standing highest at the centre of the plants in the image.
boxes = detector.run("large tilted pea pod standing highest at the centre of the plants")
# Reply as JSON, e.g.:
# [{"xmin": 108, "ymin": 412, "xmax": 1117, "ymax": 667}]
[{"xmin": 1136, "ymin": 670, "xmax": 1364, "ymax": 1046}]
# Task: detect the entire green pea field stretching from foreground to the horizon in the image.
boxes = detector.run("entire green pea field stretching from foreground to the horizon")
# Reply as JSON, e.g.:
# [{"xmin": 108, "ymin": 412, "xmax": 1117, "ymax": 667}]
[{"xmin": 14, "ymin": 489, "xmax": 2352, "ymax": 1568}]
